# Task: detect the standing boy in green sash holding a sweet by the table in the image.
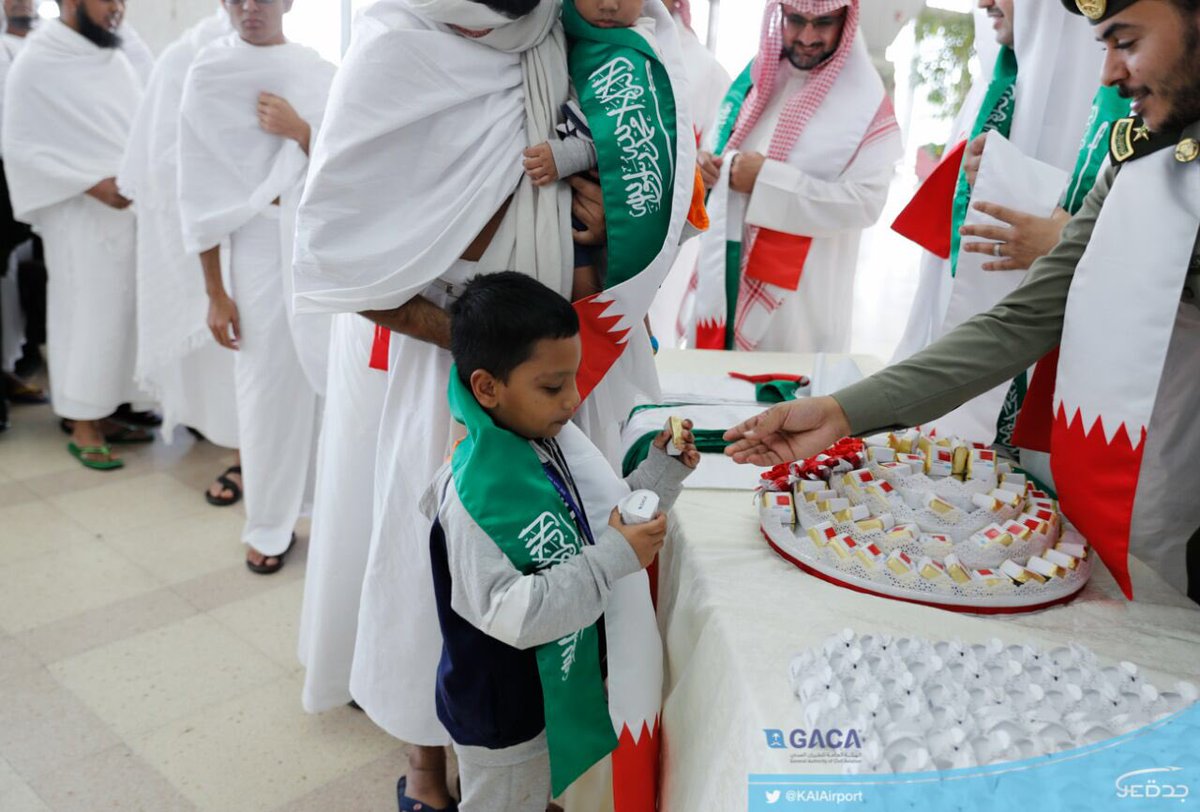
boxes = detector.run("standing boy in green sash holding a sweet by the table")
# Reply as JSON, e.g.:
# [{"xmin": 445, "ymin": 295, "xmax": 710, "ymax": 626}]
[{"xmin": 422, "ymin": 272, "xmax": 700, "ymax": 812}]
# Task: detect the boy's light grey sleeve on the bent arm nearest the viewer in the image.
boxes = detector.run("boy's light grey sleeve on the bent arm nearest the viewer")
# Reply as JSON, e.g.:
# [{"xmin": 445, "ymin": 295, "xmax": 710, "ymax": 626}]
[{"xmin": 439, "ymin": 487, "xmax": 642, "ymax": 649}]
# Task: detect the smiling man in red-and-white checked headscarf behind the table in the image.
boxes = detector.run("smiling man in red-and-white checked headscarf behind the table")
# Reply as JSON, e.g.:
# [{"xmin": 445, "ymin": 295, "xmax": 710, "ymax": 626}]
[{"xmin": 689, "ymin": 0, "xmax": 902, "ymax": 353}]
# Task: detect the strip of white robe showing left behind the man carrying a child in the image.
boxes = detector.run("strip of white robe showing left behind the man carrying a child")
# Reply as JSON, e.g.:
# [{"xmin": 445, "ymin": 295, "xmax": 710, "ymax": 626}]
[{"xmin": 299, "ymin": 313, "xmax": 386, "ymax": 714}]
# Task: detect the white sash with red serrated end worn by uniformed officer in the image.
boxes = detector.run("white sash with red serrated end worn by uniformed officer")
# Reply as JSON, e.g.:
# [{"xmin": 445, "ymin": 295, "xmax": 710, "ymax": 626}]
[{"xmin": 1051, "ymin": 149, "xmax": 1200, "ymax": 599}]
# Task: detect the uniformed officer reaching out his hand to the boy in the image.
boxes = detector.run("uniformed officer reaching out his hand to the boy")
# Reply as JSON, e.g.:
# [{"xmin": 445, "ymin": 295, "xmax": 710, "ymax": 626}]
[{"xmin": 726, "ymin": 0, "xmax": 1200, "ymax": 602}]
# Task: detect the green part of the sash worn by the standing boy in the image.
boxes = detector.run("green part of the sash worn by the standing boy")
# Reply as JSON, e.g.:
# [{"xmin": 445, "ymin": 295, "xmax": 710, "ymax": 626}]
[{"xmin": 449, "ymin": 369, "xmax": 617, "ymax": 795}]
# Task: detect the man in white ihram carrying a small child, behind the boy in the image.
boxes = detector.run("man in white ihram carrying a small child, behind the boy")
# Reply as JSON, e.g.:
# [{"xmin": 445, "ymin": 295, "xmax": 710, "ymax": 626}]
[{"xmin": 295, "ymin": 0, "xmax": 583, "ymax": 810}]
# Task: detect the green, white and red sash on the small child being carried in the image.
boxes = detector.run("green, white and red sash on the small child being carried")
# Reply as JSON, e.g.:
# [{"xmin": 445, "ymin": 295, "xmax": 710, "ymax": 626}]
[{"xmin": 563, "ymin": 0, "xmax": 696, "ymax": 397}]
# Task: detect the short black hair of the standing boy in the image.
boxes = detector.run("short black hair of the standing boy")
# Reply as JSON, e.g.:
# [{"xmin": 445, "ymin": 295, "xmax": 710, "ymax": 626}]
[{"xmin": 450, "ymin": 271, "xmax": 580, "ymax": 389}]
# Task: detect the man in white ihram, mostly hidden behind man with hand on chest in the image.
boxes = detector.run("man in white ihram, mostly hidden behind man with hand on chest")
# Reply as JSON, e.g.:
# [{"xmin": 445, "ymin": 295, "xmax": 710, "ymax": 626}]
[{"xmin": 116, "ymin": 7, "xmax": 240, "ymax": 505}]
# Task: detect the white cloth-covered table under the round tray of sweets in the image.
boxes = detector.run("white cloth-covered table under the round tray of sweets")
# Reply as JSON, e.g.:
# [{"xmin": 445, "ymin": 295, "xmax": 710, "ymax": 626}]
[{"xmin": 659, "ymin": 351, "xmax": 1200, "ymax": 812}]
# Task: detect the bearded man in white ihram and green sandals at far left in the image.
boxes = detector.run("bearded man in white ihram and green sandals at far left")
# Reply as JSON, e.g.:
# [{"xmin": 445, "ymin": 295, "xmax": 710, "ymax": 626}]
[{"xmin": 2, "ymin": 0, "xmax": 142, "ymax": 470}]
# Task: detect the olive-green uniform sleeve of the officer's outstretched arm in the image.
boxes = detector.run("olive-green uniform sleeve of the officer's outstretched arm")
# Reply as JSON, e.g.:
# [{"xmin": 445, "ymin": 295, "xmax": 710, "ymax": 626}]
[{"xmin": 833, "ymin": 160, "xmax": 1115, "ymax": 435}]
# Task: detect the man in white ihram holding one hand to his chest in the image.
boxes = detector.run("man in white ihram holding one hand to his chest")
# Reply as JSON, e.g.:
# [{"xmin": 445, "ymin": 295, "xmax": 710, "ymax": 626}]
[{"xmin": 179, "ymin": 0, "xmax": 334, "ymax": 575}]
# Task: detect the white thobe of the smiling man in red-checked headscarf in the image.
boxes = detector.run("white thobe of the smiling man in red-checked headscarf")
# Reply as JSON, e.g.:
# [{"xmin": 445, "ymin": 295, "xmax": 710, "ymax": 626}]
[{"xmin": 728, "ymin": 62, "xmax": 904, "ymax": 353}]
